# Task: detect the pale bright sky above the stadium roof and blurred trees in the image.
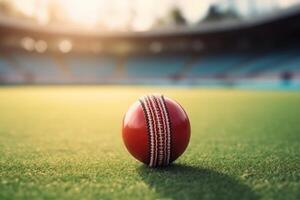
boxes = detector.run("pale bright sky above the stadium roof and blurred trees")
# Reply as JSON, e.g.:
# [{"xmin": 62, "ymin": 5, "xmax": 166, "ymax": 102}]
[{"xmin": 0, "ymin": 0, "xmax": 300, "ymax": 31}]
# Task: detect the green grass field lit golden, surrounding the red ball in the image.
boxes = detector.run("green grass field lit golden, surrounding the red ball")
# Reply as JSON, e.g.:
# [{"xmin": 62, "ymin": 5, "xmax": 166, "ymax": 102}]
[{"xmin": 0, "ymin": 86, "xmax": 300, "ymax": 200}]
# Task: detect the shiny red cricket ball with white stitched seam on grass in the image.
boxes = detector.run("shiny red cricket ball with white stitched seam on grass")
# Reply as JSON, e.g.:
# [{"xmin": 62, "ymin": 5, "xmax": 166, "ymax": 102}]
[{"xmin": 122, "ymin": 94, "xmax": 191, "ymax": 167}]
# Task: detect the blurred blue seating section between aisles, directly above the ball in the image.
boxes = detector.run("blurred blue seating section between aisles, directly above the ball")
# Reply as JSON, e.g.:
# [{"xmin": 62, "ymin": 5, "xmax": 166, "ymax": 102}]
[{"xmin": 125, "ymin": 55, "xmax": 188, "ymax": 78}]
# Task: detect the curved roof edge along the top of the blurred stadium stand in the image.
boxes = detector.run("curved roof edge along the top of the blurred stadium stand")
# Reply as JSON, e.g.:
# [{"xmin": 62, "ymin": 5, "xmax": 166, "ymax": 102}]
[{"xmin": 0, "ymin": 6, "xmax": 300, "ymax": 38}]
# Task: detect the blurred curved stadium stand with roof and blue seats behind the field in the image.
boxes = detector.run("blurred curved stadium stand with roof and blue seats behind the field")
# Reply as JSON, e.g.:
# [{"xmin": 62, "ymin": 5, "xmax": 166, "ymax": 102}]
[{"xmin": 0, "ymin": 4, "xmax": 300, "ymax": 89}]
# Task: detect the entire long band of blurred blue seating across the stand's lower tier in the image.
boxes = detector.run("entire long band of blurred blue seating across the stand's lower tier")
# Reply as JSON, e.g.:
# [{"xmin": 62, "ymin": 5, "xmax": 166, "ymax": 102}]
[{"xmin": 0, "ymin": 49, "xmax": 300, "ymax": 85}]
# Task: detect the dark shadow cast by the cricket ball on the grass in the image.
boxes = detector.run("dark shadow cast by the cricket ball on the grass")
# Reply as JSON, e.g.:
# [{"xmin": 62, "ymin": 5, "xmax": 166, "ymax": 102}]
[{"xmin": 137, "ymin": 164, "xmax": 258, "ymax": 200}]
